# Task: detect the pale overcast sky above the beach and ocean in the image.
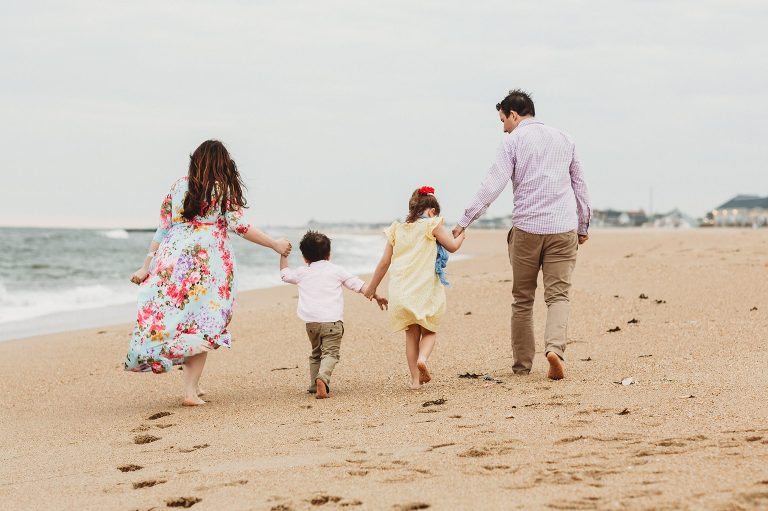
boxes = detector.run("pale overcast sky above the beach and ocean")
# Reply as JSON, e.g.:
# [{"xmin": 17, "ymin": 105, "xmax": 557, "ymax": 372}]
[{"xmin": 0, "ymin": 0, "xmax": 768, "ymax": 228}]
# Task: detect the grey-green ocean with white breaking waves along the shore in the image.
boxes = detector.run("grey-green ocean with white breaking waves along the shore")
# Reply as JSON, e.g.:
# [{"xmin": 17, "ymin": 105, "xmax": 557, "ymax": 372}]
[{"xmin": 0, "ymin": 227, "xmax": 385, "ymax": 340}]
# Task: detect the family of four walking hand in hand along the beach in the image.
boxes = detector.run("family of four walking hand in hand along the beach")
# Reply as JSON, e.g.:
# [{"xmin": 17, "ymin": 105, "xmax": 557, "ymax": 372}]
[{"xmin": 125, "ymin": 90, "xmax": 591, "ymax": 406}]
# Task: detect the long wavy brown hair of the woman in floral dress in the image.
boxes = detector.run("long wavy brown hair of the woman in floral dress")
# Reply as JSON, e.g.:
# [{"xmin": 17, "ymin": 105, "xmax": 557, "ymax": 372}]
[{"xmin": 182, "ymin": 140, "xmax": 246, "ymax": 220}]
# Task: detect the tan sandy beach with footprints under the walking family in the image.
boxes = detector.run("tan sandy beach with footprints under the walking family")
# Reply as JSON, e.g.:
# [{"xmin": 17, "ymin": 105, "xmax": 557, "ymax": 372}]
[{"xmin": 0, "ymin": 230, "xmax": 768, "ymax": 511}]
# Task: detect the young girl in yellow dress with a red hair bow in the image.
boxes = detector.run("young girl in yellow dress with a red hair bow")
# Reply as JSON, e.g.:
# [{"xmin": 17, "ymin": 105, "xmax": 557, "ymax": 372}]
[{"xmin": 365, "ymin": 186, "xmax": 464, "ymax": 389}]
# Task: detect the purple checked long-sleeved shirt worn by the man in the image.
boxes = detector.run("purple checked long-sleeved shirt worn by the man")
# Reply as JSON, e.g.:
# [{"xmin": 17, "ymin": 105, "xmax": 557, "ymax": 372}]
[{"xmin": 459, "ymin": 118, "xmax": 592, "ymax": 234}]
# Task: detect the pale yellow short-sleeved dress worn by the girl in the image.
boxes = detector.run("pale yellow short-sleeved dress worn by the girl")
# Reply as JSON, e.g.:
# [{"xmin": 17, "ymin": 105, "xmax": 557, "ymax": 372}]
[{"xmin": 384, "ymin": 216, "xmax": 445, "ymax": 332}]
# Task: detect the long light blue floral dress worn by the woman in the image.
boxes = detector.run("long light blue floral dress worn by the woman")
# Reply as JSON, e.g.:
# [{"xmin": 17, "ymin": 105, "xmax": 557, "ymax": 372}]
[{"xmin": 125, "ymin": 177, "xmax": 250, "ymax": 373}]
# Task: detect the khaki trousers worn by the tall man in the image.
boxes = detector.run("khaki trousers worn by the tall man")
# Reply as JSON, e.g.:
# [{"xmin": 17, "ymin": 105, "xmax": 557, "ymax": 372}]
[{"xmin": 507, "ymin": 228, "xmax": 579, "ymax": 374}]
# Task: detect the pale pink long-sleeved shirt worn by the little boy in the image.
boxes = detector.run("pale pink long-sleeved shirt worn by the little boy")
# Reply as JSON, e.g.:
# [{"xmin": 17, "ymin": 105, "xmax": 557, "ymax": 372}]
[{"xmin": 280, "ymin": 261, "xmax": 365, "ymax": 323}]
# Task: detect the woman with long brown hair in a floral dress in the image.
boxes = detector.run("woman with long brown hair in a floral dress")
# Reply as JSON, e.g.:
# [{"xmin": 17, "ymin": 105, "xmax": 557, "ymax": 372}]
[{"xmin": 125, "ymin": 140, "xmax": 291, "ymax": 406}]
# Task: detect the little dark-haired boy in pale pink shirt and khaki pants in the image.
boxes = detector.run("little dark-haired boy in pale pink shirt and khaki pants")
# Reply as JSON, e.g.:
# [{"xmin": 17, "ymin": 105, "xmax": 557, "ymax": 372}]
[{"xmin": 280, "ymin": 231, "xmax": 387, "ymax": 399}]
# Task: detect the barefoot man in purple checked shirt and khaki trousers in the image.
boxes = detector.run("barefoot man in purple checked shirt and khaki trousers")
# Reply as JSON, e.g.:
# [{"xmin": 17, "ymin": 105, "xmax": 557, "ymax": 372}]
[{"xmin": 453, "ymin": 89, "xmax": 591, "ymax": 380}]
